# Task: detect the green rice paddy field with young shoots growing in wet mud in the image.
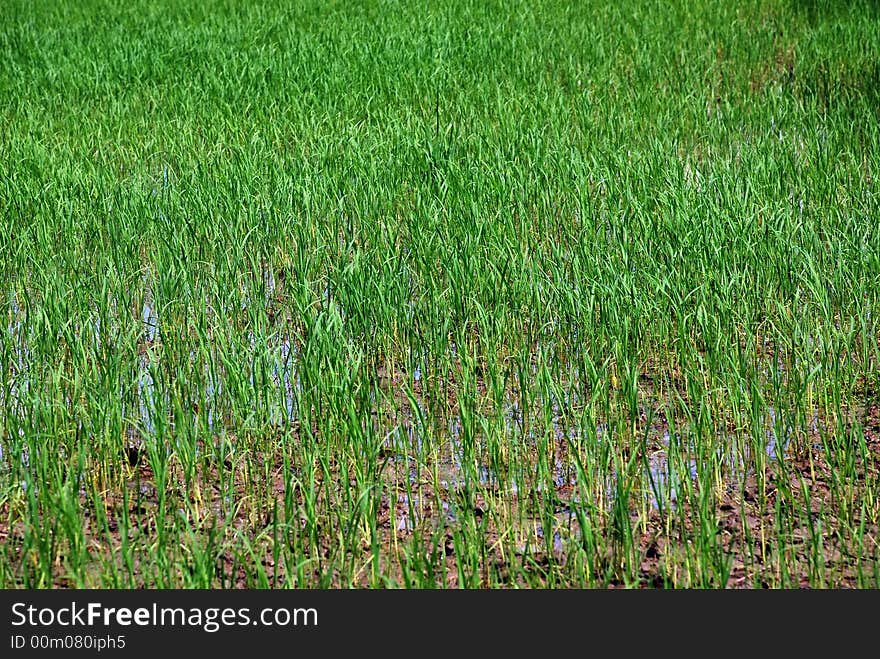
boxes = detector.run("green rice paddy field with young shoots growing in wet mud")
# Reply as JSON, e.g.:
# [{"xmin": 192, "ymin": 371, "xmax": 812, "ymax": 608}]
[{"xmin": 0, "ymin": 0, "xmax": 880, "ymax": 589}]
